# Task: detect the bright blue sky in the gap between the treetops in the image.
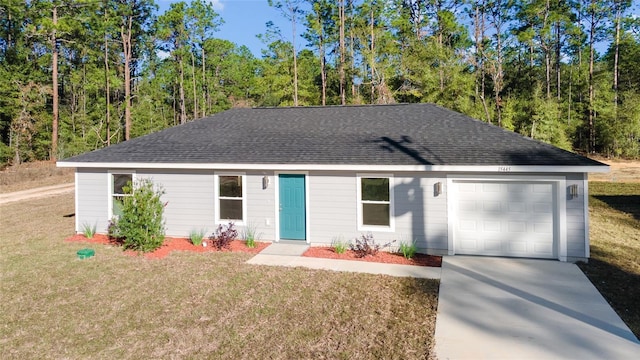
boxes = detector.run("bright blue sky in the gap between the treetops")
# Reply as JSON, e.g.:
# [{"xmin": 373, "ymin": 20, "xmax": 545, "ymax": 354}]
[{"xmin": 156, "ymin": 0, "xmax": 306, "ymax": 57}]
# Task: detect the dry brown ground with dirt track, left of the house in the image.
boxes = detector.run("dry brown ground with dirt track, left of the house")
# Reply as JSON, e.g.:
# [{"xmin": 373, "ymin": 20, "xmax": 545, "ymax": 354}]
[{"xmin": 0, "ymin": 161, "xmax": 74, "ymax": 194}]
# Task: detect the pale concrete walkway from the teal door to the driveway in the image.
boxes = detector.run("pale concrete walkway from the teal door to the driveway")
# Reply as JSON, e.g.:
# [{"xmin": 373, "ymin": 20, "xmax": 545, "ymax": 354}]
[{"xmin": 247, "ymin": 242, "xmax": 440, "ymax": 279}]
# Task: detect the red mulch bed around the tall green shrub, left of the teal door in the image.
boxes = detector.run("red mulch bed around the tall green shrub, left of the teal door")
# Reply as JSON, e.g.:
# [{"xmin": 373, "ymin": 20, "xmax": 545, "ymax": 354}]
[{"xmin": 65, "ymin": 234, "xmax": 270, "ymax": 259}]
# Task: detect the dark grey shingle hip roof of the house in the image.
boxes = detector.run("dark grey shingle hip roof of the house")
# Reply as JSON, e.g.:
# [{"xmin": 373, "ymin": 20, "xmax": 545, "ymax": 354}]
[{"xmin": 63, "ymin": 104, "xmax": 603, "ymax": 166}]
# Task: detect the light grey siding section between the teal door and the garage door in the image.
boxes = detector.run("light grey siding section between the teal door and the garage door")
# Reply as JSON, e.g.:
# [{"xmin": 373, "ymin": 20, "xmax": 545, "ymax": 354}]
[{"xmin": 308, "ymin": 172, "xmax": 448, "ymax": 252}]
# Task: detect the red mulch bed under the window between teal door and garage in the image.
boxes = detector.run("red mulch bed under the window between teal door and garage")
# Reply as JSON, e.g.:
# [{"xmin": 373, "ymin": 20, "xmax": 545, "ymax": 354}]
[{"xmin": 302, "ymin": 246, "xmax": 442, "ymax": 267}]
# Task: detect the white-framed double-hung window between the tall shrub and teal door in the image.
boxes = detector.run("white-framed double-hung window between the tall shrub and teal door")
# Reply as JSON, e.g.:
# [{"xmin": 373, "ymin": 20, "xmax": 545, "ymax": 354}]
[{"xmin": 216, "ymin": 174, "xmax": 246, "ymax": 222}]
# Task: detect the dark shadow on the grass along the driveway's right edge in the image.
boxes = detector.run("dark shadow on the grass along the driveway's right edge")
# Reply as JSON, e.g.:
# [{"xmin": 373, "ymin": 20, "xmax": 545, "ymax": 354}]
[{"xmin": 577, "ymin": 258, "xmax": 640, "ymax": 339}]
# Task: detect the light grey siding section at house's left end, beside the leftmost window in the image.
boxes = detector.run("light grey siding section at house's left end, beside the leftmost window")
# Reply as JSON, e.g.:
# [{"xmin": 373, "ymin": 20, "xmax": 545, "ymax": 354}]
[{"xmin": 76, "ymin": 169, "xmax": 109, "ymax": 233}]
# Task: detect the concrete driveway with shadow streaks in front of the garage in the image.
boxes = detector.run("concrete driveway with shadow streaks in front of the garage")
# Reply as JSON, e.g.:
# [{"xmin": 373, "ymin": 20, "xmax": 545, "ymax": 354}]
[{"xmin": 435, "ymin": 256, "xmax": 640, "ymax": 360}]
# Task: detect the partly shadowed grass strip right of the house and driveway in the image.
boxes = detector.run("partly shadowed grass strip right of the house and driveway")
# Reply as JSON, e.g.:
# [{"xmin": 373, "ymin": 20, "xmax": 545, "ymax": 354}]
[{"xmin": 580, "ymin": 182, "xmax": 640, "ymax": 337}]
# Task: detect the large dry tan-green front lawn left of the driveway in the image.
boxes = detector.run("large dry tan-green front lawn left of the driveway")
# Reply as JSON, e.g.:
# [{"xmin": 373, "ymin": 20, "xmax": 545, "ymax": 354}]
[{"xmin": 0, "ymin": 195, "xmax": 438, "ymax": 359}]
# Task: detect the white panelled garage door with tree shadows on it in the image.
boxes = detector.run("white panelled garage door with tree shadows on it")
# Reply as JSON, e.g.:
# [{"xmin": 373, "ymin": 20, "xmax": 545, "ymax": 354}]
[{"xmin": 454, "ymin": 181, "xmax": 556, "ymax": 258}]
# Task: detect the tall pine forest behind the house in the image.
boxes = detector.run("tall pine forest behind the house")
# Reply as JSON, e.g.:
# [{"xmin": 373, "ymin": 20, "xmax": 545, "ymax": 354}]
[{"xmin": 0, "ymin": 0, "xmax": 640, "ymax": 165}]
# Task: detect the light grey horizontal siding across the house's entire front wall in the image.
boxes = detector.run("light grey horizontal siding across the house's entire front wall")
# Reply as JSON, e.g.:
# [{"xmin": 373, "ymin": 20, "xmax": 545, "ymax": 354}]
[{"xmin": 76, "ymin": 169, "xmax": 585, "ymax": 258}]
